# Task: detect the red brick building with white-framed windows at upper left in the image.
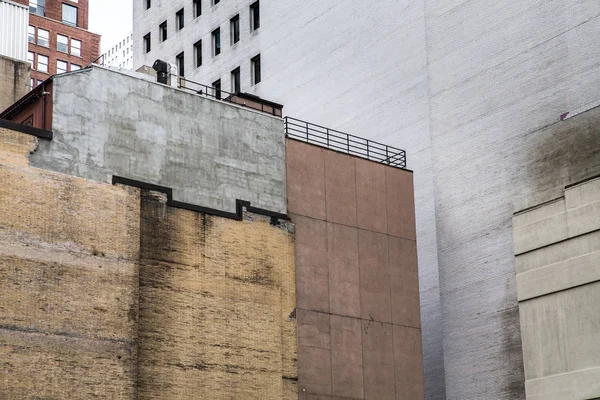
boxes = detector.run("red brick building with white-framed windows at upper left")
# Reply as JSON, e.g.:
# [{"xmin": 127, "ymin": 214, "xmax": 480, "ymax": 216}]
[{"xmin": 16, "ymin": 0, "xmax": 100, "ymax": 87}]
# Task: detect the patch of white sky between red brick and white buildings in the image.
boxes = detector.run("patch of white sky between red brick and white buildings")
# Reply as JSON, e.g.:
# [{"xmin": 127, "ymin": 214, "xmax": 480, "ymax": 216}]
[{"xmin": 89, "ymin": 0, "xmax": 133, "ymax": 53}]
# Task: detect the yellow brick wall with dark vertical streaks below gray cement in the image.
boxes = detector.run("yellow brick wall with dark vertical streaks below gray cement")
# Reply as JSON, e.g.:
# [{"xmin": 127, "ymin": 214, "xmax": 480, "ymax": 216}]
[{"xmin": 0, "ymin": 129, "xmax": 297, "ymax": 400}]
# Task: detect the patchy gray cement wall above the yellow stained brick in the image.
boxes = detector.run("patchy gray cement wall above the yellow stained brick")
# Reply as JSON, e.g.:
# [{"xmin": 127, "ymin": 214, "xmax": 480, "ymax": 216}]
[{"xmin": 31, "ymin": 67, "xmax": 286, "ymax": 213}]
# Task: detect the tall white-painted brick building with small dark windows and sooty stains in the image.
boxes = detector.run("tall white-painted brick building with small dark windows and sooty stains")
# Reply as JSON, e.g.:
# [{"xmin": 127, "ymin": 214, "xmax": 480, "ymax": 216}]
[{"xmin": 134, "ymin": 0, "xmax": 600, "ymax": 400}]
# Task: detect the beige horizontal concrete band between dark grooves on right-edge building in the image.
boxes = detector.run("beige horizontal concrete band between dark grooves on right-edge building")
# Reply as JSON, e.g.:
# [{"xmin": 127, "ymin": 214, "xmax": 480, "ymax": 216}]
[{"xmin": 517, "ymin": 251, "xmax": 600, "ymax": 301}]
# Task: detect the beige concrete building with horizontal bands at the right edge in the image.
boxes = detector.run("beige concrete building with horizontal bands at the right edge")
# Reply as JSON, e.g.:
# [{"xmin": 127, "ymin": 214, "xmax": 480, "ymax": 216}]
[{"xmin": 513, "ymin": 178, "xmax": 600, "ymax": 400}]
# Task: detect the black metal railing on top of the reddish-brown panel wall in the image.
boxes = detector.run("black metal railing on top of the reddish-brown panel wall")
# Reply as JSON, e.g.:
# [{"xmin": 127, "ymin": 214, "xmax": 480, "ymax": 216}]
[{"xmin": 285, "ymin": 117, "xmax": 406, "ymax": 169}]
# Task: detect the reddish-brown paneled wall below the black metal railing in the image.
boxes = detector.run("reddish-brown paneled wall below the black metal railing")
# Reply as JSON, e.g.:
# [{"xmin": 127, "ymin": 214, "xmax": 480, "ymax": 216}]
[{"xmin": 286, "ymin": 140, "xmax": 424, "ymax": 400}]
